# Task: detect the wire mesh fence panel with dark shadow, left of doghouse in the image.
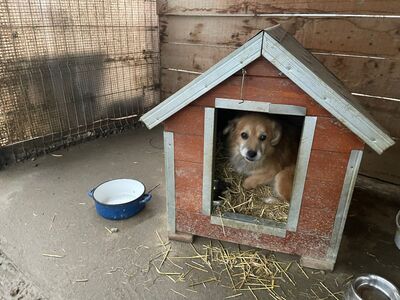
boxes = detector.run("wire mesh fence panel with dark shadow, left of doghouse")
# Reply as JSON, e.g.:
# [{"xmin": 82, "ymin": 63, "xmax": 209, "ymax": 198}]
[{"xmin": 0, "ymin": 0, "xmax": 159, "ymax": 163}]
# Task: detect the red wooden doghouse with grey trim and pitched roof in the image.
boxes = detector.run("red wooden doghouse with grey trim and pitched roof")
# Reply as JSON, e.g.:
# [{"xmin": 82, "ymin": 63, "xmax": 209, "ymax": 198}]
[{"xmin": 141, "ymin": 25, "xmax": 394, "ymax": 269}]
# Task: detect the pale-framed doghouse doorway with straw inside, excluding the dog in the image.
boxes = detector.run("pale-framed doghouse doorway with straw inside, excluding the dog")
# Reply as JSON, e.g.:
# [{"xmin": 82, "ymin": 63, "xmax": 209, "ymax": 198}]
[{"xmin": 202, "ymin": 98, "xmax": 316, "ymax": 237}]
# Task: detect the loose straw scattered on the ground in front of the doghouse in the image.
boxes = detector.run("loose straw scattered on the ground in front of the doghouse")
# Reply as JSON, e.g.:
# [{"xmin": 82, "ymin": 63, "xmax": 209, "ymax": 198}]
[{"xmin": 149, "ymin": 235, "xmax": 343, "ymax": 300}]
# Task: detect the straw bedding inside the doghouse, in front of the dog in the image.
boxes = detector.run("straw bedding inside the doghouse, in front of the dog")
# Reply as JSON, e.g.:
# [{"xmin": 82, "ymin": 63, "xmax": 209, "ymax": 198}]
[{"xmin": 215, "ymin": 151, "xmax": 289, "ymax": 223}]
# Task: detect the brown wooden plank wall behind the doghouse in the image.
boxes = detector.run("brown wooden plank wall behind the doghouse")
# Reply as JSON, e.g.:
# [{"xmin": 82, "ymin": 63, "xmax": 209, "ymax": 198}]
[{"xmin": 158, "ymin": 0, "xmax": 400, "ymax": 184}]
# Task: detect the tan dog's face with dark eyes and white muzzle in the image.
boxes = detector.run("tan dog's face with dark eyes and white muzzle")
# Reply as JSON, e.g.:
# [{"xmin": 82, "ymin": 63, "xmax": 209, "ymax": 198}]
[{"xmin": 223, "ymin": 114, "xmax": 282, "ymax": 162}]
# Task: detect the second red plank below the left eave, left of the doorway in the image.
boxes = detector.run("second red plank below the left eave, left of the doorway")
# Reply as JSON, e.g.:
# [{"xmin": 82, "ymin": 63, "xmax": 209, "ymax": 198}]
[{"xmin": 174, "ymin": 133, "xmax": 204, "ymax": 163}]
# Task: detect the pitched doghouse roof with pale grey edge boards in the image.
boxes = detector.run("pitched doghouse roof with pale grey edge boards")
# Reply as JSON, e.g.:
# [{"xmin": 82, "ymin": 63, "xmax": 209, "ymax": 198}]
[{"xmin": 140, "ymin": 25, "xmax": 394, "ymax": 154}]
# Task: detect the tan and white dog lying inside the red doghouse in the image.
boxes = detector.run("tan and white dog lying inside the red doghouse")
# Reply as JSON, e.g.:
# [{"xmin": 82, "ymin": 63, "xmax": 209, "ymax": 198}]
[{"xmin": 223, "ymin": 113, "xmax": 298, "ymax": 203}]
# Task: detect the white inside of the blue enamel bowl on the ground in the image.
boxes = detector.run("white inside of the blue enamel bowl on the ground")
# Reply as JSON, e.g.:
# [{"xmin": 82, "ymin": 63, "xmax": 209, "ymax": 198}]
[{"xmin": 93, "ymin": 179, "xmax": 145, "ymax": 205}]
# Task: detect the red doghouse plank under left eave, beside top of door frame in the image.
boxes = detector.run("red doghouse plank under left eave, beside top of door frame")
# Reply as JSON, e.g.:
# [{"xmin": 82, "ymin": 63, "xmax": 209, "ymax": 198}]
[{"xmin": 164, "ymin": 106, "xmax": 204, "ymax": 135}]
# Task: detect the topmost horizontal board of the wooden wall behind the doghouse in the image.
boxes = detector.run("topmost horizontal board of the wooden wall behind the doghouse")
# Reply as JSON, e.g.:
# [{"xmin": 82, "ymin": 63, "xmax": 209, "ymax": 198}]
[{"xmin": 158, "ymin": 0, "xmax": 400, "ymax": 15}]
